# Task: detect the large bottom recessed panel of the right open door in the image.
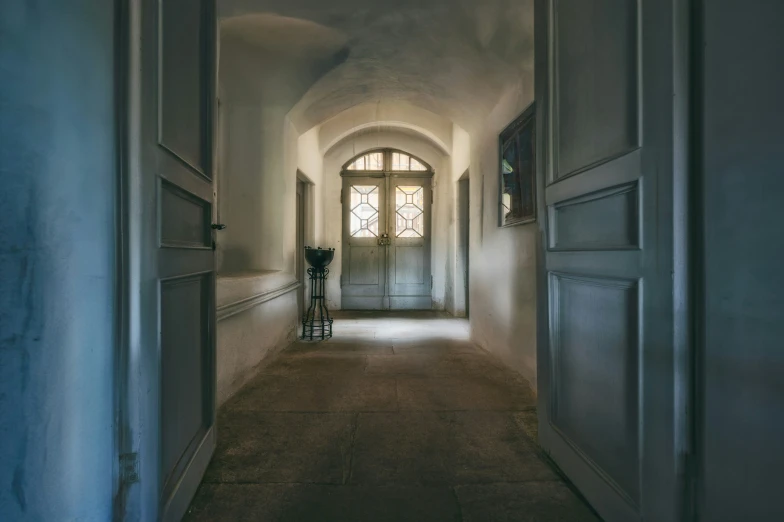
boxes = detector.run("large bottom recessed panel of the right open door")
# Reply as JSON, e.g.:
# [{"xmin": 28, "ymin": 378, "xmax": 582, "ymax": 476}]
[{"xmin": 550, "ymin": 272, "xmax": 639, "ymax": 503}]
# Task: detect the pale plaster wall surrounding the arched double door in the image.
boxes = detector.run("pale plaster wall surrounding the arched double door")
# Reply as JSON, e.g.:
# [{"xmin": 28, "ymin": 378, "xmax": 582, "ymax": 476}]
[{"xmin": 321, "ymin": 129, "xmax": 452, "ymax": 310}]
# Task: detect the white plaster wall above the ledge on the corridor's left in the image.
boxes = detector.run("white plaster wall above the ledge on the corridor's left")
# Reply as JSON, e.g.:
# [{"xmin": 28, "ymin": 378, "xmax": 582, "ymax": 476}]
[{"xmin": 218, "ymin": 37, "xmax": 299, "ymax": 273}]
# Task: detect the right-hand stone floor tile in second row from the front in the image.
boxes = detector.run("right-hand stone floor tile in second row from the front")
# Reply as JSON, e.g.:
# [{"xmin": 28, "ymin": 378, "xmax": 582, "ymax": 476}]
[{"xmin": 350, "ymin": 412, "xmax": 558, "ymax": 485}]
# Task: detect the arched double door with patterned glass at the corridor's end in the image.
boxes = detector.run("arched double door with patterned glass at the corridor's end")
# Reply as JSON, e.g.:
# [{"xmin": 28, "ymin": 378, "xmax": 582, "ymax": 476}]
[{"xmin": 341, "ymin": 149, "xmax": 433, "ymax": 310}]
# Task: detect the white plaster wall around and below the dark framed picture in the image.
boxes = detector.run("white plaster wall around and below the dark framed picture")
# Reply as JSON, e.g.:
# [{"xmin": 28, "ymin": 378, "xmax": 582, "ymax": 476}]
[{"xmin": 470, "ymin": 77, "xmax": 542, "ymax": 389}]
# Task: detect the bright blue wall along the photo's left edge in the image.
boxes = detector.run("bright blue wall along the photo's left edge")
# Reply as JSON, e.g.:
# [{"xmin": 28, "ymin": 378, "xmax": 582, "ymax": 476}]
[{"xmin": 0, "ymin": 0, "xmax": 117, "ymax": 521}]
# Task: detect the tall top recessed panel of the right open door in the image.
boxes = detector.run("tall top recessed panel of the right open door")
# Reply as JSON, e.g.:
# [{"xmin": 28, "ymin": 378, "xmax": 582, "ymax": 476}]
[{"xmin": 552, "ymin": 0, "xmax": 639, "ymax": 179}]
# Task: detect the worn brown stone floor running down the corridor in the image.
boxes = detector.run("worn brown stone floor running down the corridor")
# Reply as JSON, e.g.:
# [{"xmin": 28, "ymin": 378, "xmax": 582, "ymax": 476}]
[{"xmin": 185, "ymin": 313, "xmax": 598, "ymax": 522}]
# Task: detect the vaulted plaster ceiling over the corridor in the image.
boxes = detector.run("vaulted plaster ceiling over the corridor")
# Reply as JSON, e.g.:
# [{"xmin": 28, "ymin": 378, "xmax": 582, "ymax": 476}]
[{"xmin": 218, "ymin": 0, "xmax": 533, "ymax": 132}]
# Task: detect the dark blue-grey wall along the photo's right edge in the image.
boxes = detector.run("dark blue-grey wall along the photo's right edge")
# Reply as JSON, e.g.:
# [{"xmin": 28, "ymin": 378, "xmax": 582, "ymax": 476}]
[{"xmin": 698, "ymin": 0, "xmax": 784, "ymax": 522}]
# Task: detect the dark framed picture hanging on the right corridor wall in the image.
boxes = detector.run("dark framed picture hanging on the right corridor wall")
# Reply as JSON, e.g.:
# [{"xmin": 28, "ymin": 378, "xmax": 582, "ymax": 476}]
[{"xmin": 498, "ymin": 103, "xmax": 536, "ymax": 227}]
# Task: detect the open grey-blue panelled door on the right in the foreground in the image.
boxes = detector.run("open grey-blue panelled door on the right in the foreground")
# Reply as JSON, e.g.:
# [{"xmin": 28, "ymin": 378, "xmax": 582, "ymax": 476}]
[{"xmin": 536, "ymin": 0, "xmax": 688, "ymax": 522}]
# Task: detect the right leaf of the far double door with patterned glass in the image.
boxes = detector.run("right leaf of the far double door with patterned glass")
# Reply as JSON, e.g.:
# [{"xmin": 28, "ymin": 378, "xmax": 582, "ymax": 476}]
[{"xmin": 387, "ymin": 175, "xmax": 432, "ymax": 310}]
